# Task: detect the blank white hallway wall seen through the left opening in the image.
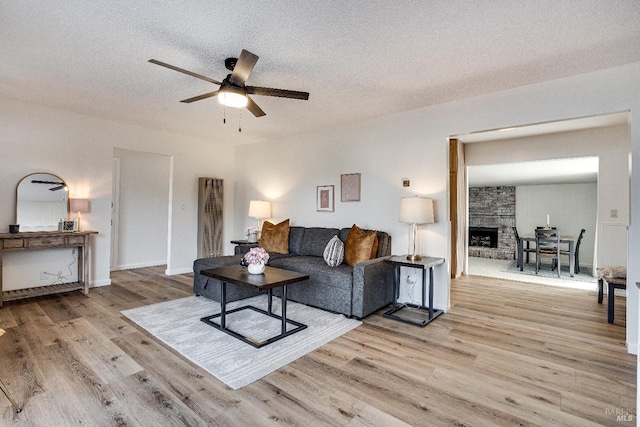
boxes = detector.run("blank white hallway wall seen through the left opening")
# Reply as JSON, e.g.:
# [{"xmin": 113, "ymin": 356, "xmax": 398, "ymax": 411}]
[{"xmin": 113, "ymin": 148, "xmax": 170, "ymax": 269}]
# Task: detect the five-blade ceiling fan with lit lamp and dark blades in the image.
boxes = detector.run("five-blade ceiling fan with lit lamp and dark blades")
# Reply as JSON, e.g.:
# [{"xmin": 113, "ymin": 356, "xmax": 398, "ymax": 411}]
[{"xmin": 149, "ymin": 49, "xmax": 309, "ymax": 117}]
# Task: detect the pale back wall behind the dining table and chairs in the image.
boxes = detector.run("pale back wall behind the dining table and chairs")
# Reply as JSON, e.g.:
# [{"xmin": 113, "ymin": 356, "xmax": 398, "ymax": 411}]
[{"xmin": 516, "ymin": 183, "xmax": 598, "ymax": 267}]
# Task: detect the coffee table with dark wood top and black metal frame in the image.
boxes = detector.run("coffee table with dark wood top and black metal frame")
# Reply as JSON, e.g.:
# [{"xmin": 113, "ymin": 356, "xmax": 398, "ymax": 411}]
[{"xmin": 200, "ymin": 265, "xmax": 309, "ymax": 348}]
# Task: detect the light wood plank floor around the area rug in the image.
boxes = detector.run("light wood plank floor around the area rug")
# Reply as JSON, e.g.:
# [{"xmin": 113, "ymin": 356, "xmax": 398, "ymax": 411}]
[{"xmin": 0, "ymin": 268, "xmax": 636, "ymax": 427}]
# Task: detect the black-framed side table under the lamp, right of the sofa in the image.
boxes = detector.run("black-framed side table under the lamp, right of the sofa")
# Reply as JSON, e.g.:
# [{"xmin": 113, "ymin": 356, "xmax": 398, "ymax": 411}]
[{"xmin": 383, "ymin": 255, "xmax": 444, "ymax": 327}]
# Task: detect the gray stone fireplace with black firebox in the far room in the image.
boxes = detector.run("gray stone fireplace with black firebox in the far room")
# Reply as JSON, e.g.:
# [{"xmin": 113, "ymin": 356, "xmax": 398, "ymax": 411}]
[{"xmin": 469, "ymin": 186, "xmax": 516, "ymax": 259}]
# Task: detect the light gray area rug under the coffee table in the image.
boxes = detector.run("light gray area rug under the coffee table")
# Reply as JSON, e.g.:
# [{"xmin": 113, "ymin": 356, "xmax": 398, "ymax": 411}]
[{"xmin": 121, "ymin": 295, "xmax": 362, "ymax": 390}]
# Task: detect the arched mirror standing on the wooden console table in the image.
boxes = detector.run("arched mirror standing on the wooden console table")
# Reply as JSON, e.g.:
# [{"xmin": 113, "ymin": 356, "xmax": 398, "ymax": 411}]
[{"xmin": 16, "ymin": 173, "xmax": 69, "ymax": 231}]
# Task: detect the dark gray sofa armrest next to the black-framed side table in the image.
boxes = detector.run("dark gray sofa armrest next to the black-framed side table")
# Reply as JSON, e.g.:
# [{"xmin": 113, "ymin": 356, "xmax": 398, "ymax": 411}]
[{"xmin": 351, "ymin": 256, "xmax": 393, "ymax": 318}]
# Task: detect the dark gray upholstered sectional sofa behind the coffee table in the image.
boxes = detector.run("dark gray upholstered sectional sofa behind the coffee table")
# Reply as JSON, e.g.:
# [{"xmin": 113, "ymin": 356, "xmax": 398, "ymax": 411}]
[{"xmin": 193, "ymin": 227, "xmax": 393, "ymax": 318}]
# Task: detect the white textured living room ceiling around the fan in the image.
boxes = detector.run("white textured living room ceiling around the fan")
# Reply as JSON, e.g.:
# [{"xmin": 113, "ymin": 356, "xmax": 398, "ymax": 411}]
[{"xmin": 0, "ymin": 0, "xmax": 640, "ymax": 144}]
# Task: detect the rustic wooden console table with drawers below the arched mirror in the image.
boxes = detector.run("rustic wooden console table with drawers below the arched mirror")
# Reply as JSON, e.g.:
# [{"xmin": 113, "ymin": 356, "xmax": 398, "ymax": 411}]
[{"xmin": 0, "ymin": 231, "xmax": 98, "ymax": 308}]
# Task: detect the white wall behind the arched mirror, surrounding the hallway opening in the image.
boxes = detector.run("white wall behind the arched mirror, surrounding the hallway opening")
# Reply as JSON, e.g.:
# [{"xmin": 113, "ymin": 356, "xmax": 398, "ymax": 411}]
[{"xmin": 0, "ymin": 97, "xmax": 234, "ymax": 288}]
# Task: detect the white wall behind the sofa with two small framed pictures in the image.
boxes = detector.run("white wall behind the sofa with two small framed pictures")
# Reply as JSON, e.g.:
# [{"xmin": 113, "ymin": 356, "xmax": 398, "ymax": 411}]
[{"xmin": 235, "ymin": 63, "xmax": 640, "ymax": 353}]
